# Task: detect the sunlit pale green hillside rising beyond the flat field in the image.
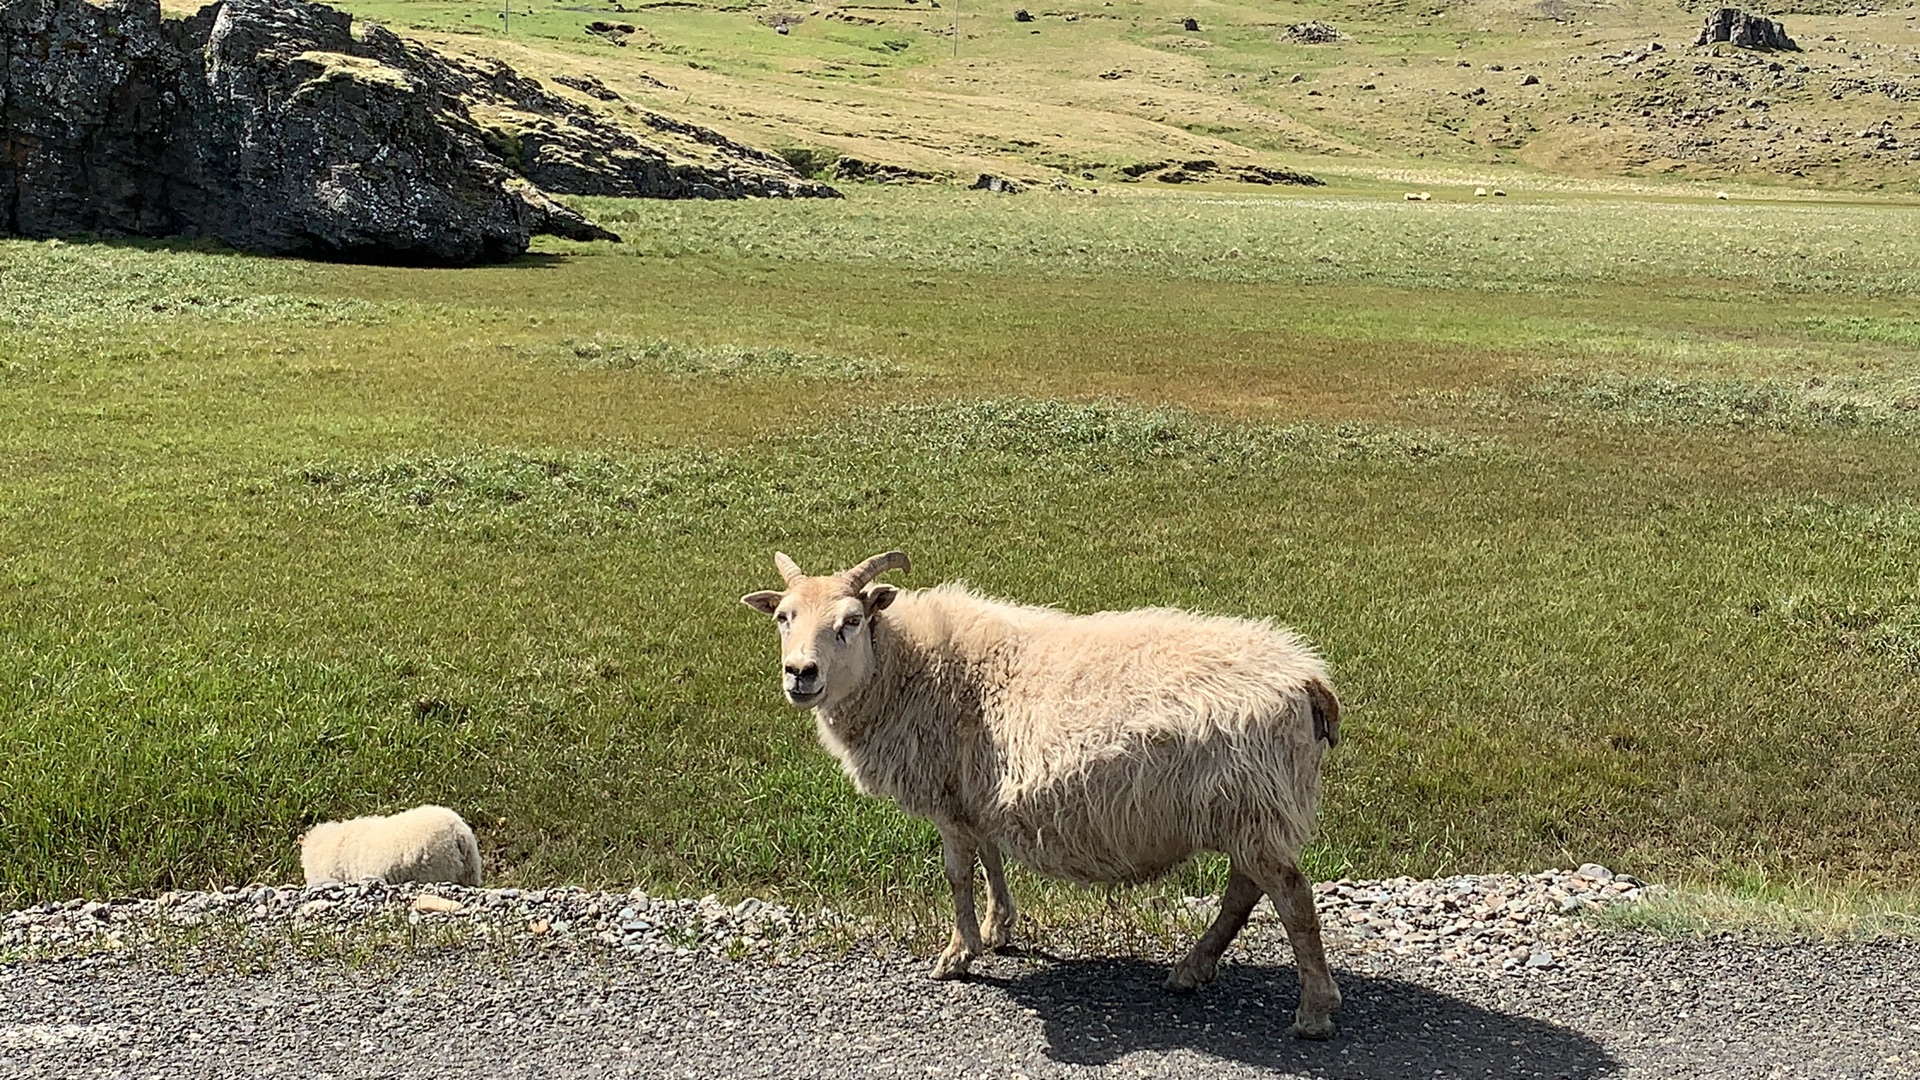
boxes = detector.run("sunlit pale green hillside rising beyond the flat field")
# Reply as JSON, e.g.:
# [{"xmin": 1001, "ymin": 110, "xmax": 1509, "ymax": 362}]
[{"xmin": 214, "ymin": 0, "xmax": 1920, "ymax": 194}]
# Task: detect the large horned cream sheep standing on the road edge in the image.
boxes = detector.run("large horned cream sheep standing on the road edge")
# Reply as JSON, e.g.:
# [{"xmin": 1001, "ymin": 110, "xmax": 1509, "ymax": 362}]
[{"xmin": 741, "ymin": 552, "xmax": 1340, "ymax": 1038}]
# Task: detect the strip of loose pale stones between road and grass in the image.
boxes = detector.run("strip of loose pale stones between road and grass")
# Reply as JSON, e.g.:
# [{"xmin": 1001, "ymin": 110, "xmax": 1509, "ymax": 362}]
[{"xmin": 0, "ymin": 865, "xmax": 1657, "ymax": 960}]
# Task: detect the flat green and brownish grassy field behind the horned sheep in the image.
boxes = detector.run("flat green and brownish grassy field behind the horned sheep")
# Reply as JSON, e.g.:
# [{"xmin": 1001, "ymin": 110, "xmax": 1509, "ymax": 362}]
[{"xmin": 0, "ymin": 186, "xmax": 1920, "ymax": 907}]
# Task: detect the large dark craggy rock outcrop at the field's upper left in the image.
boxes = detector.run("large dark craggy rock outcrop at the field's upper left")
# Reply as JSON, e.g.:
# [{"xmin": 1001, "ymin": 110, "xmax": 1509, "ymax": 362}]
[{"xmin": 0, "ymin": 0, "xmax": 831, "ymax": 263}]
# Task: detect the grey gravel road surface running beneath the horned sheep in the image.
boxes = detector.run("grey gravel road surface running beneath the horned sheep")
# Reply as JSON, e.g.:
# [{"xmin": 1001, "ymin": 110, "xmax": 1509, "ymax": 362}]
[{"xmin": 0, "ymin": 884, "xmax": 1920, "ymax": 1080}]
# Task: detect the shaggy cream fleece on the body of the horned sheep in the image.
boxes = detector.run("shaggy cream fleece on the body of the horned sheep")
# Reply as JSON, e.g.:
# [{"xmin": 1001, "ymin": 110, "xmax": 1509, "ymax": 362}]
[{"xmin": 820, "ymin": 586, "xmax": 1331, "ymax": 884}]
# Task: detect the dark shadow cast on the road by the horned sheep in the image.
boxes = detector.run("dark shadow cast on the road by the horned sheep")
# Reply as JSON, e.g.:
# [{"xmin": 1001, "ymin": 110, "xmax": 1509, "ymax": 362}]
[{"xmin": 975, "ymin": 959, "xmax": 1620, "ymax": 1080}]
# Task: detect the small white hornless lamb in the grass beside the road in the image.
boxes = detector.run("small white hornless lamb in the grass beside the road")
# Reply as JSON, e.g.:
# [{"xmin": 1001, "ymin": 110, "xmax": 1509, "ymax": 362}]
[{"xmin": 300, "ymin": 805, "xmax": 480, "ymax": 886}]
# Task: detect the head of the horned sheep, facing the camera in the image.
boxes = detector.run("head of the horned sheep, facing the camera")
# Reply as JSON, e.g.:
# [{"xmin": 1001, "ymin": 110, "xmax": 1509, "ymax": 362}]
[{"xmin": 741, "ymin": 555, "xmax": 904, "ymax": 709}]
